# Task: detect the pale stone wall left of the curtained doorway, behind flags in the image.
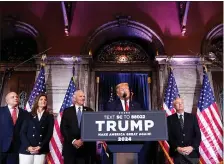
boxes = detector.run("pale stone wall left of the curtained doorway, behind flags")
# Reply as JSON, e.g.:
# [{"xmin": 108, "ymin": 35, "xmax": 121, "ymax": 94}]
[{"xmin": 37, "ymin": 57, "xmax": 94, "ymax": 113}]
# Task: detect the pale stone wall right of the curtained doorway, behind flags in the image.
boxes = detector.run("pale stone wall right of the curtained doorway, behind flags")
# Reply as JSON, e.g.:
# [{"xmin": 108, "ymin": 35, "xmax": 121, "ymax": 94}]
[{"xmin": 156, "ymin": 55, "xmax": 217, "ymax": 113}]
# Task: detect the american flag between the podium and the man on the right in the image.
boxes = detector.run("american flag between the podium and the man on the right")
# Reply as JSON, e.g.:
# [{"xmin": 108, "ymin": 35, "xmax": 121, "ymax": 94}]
[{"xmin": 159, "ymin": 69, "xmax": 179, "ymax": 163}]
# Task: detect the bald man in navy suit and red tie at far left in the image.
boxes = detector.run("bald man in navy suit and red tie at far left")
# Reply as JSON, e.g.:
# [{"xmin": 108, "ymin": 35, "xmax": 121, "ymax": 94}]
[{"xmin": 0, "ymin": 92, "xmax": 28, "ymax": 164}]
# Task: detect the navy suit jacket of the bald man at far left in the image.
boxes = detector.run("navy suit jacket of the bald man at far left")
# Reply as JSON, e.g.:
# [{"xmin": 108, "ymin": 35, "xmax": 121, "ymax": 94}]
[{"xmin": 0, "ymin": 106, "xmax": 28, "ymax": 153}]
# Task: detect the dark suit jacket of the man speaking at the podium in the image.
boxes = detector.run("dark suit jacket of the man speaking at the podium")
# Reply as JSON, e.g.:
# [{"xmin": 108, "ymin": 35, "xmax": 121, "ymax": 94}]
[{"xmin": 104, "ymin": 99, "xmax": 143, "ymax": 111}]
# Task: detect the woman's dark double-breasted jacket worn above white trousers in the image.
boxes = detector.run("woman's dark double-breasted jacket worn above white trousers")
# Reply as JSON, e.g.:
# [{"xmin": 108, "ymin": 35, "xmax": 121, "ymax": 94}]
[{"xmin": 19, "ymin": 111, "xmax": 54, "ymax": 154}]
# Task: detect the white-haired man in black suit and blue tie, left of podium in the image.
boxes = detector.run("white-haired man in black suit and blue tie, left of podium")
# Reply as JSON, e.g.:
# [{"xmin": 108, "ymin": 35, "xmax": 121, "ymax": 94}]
[{"xmin": 61, "ymin": 90, "xmax": 96, "ymax": 164}]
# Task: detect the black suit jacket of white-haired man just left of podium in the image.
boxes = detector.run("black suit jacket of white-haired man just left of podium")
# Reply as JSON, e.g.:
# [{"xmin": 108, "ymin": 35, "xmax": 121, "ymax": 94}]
[{"xmin": 60, "ymin": 106, "xmax": 96, "ymax": 157}]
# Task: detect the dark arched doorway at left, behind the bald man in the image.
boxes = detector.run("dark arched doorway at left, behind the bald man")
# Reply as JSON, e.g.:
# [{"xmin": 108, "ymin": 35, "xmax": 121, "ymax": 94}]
[{"xmin": 0, "ymin": 17, "xmax": 43, "ymax": 108}]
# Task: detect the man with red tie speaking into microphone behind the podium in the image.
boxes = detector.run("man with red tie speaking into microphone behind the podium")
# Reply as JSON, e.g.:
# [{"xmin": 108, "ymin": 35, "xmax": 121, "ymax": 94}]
[{"xmin": 105, "ymin": 83, "xmax": 143, "ymax": 112}]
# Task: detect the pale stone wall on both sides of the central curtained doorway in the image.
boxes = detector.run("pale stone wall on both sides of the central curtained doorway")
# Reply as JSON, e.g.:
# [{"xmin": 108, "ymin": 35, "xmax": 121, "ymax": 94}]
[{"xmin": 33, "ymin": 56, "xmax": 220, "ymax": 113}]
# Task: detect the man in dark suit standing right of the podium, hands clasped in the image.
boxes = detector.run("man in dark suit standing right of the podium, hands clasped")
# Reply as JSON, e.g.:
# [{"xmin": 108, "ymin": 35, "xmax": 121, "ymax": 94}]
[{"xmin": 167, "ymin": 98, "xmax": 201, "ymax": 164}]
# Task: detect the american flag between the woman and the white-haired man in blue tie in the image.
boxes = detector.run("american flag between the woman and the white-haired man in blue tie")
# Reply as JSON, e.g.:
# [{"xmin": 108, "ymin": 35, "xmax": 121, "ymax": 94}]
[{"xmin": 47, "ymin": 77, "xmax": 76, "ymax": 164}]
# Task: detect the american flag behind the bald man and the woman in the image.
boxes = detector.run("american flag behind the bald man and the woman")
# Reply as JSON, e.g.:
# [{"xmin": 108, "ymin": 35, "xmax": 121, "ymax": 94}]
[{"xmin": 25, "ymin": 66, "xmax": 46, "ymax": 112}]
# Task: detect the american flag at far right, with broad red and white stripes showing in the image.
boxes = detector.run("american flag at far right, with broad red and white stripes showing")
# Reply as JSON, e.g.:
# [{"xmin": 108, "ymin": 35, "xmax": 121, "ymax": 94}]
[{"xmin": 197, "ymin": 68, "xmax": 223, "ymax": 164}]
